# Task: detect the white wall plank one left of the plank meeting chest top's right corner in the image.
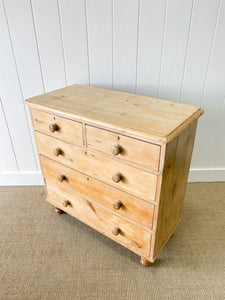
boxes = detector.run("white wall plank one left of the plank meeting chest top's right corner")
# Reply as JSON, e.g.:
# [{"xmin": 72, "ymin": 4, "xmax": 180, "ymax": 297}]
[{"xmin": 158, "ymin": 0, "xmax": 193, "ymax": 101}]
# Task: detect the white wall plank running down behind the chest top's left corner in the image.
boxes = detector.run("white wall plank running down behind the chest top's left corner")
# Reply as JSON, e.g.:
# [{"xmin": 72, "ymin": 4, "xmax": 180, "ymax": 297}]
[{"xmin": 5, "ymin": 0, "xmax": 44, "ymax": 170}]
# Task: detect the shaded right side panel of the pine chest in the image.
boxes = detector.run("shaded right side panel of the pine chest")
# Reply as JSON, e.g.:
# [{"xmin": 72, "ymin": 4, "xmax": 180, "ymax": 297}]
[{"xmin": 152, "ymin": 120, "xmax": 197, "ymax": 258}]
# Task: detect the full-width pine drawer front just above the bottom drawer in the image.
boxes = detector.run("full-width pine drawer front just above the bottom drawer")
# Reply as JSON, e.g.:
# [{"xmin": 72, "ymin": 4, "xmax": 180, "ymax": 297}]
[{"xmin": 40, "ymin": 156, "xmax": 154, "ymax": 230}]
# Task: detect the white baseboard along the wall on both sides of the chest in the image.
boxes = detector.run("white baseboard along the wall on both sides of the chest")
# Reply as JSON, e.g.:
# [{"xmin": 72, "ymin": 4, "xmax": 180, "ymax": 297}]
[{"xmin": 0, "ymin": 168, "xmax": 225, "ymax": 186}]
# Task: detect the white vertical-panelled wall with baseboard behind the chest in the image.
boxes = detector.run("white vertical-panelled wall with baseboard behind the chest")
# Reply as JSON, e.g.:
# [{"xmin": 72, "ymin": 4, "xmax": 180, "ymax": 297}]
[{"xmin": 0, "ymin": 0, "xmax": 225, "ymax": 185}]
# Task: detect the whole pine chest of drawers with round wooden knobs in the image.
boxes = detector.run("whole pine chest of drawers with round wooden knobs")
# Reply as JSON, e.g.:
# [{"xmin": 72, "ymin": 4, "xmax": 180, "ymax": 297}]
[{"xmin": 26, "ymin": 85, "xmax": 203, "ymax": 266}]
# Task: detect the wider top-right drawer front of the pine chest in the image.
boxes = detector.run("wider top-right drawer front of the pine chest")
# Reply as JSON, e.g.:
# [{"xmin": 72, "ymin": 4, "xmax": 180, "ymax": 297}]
[{"xmin": 86, "ymin": 125, "xmax": 160, "ymax": 171}]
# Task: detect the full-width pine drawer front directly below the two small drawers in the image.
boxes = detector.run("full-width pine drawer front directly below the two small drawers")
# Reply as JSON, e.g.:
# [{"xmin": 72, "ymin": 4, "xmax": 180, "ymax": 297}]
[{"xmin": 35, "ymin": 132, "xmax": 157, "ymax": 201}]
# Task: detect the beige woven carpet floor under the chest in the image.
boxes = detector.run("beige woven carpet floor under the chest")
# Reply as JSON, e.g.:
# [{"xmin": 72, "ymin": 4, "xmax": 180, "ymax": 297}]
[{"xmin": 0, "ymin": 182, "xmax": 225, "ymax": 300}]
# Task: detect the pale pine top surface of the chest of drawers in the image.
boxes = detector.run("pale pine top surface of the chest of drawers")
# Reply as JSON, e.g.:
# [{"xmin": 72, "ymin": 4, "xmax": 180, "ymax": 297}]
[{"xmin": 26, "ymin": 84, "xmax": 203, "ymax": 142}]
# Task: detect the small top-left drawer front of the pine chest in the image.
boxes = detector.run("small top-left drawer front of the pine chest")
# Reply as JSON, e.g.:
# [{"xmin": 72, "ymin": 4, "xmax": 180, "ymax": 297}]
[{"xmin": 30, "ymin": 109, "xmax": 83, "ymax": 146}]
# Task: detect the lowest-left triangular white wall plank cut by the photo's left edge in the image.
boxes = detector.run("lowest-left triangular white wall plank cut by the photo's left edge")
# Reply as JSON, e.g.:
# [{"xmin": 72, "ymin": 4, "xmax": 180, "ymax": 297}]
[{"xmin": 0, "ymin": 99, "xmax": 19, "ymax": 173}]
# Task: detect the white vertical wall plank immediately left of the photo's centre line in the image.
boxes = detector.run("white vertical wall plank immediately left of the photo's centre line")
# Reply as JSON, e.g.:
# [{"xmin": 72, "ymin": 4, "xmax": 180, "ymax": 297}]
[{"xmin": 86, "ymin": 0, "xmax": 112, "ymax": 88}]
